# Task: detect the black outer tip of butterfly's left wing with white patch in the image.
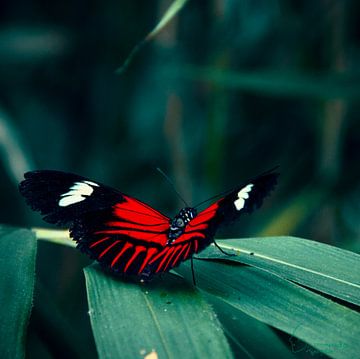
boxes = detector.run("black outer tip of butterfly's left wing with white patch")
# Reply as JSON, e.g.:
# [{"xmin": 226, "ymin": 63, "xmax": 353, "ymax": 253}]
[{"xmin": 19, "ymin": 170, "xmax": 124, "ymax": 226}]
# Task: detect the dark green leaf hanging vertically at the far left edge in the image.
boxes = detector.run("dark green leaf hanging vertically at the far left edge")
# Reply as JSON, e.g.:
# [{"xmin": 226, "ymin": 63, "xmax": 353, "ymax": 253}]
[{"xmin": 0, "ymin": 226, "xmax": 36, "ymax": 358}]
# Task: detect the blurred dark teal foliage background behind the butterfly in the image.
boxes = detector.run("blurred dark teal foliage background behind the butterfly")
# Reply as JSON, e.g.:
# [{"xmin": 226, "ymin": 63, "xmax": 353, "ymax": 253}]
[{"xmin": 0, "ymin": 0, "xmax": 360, "ymax": 357}]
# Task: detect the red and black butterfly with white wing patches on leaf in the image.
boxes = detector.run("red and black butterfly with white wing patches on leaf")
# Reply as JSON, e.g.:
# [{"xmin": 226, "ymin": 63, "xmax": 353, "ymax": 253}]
[{"xmin": 19, "ymin": 170, "xmax": 278, "ymax": 277}]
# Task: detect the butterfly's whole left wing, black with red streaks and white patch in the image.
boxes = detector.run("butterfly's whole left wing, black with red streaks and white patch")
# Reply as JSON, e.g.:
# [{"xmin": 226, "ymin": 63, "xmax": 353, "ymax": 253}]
[{"xmin": 19, "ymin": 170, "xmax": 169, "ymax": 274}]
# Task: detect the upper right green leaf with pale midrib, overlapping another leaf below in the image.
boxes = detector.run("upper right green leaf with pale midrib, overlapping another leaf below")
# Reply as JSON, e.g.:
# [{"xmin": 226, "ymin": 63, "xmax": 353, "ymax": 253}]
[{"xmin": 200, "ymin": 237, "xmax": 360, "ymax": 305}]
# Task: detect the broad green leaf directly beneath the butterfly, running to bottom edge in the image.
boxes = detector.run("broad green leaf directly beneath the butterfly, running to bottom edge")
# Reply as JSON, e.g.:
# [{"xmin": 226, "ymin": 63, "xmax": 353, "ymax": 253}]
[{"xmin": 85, "ymin": 265, "xmax": 232, "ymax": 358}]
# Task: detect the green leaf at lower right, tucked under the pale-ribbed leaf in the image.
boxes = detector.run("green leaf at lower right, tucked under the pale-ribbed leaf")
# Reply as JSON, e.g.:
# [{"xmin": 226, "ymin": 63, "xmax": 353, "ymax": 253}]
[{"xmin": 178, "ymin": 260, "xmax": 360, "ymax": 358}]
